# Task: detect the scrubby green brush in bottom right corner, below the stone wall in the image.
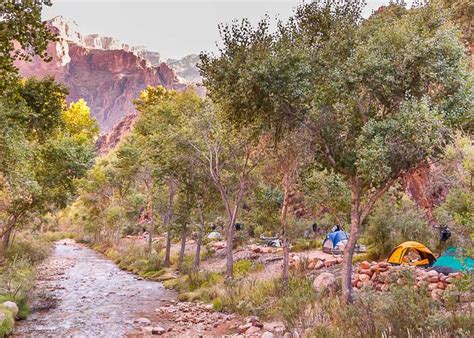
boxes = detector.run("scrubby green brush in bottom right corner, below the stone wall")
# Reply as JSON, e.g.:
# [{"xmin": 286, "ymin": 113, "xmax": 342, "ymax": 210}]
[{"xmin": 311, "ymin": 286, "xmax": 473, "ymax": 337}]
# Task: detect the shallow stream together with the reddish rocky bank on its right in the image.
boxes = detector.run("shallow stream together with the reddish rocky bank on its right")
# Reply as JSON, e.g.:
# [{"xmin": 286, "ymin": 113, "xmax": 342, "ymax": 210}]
[{"xmin": 13, "ymin": 241, "xmax": 241, "ymax": 337}]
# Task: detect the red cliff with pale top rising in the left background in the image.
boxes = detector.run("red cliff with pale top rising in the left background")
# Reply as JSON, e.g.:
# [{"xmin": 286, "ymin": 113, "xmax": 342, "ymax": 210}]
[{"xmin": 16, "ymin": 17, "xmax": 186, "ymax": 133}]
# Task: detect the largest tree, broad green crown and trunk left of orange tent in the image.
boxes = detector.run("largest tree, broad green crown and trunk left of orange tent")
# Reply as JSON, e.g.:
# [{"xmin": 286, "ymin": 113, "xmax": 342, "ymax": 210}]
[{"xmin": 201, "ymin": 1, "xmax": 473, "ymax": 302}]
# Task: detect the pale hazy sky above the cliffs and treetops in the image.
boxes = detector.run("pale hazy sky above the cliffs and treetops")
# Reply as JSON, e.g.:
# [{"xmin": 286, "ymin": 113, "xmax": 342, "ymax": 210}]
[{"xmin": 43, "ymin": 0, "xmax": 398, "ymax": 58}]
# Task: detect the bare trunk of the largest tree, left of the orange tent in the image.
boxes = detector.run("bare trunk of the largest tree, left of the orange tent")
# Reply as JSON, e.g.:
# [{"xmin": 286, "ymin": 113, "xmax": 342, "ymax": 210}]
[{"xmin": 342, "ymin": 182, "xmax": 360, "ymax": 303}]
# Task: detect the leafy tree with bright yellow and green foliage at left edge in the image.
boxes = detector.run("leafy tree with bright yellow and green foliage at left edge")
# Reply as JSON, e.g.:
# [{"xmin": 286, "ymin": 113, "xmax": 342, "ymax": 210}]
[{"xmin": 0, "ymin": 79, "xmax": 97, "ymax": 251}]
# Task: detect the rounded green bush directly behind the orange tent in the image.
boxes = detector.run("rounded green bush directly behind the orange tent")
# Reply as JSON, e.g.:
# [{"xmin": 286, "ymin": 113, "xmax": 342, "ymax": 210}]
[{"xmin": 362, "ymin": 196, "xmax": 437, "ymax": 260}]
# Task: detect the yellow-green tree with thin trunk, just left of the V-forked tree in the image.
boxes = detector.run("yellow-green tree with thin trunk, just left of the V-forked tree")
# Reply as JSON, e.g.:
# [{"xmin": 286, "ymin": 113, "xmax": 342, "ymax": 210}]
[{"xmin": 134, "ymin": 86, "xmax": 201, "ymax": 266}]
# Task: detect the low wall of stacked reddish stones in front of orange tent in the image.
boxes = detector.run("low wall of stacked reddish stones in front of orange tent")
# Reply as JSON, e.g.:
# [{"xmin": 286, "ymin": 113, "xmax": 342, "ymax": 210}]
[{"xmin": 352, "ymin": 261, "xmax": 462, "ymax": 299}]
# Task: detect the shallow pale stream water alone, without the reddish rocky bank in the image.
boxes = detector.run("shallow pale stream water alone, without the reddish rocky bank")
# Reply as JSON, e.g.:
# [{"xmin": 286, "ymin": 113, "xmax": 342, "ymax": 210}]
[{"xmin": 15, "ymin": 245, "xmax": 176, "ymax": 337}]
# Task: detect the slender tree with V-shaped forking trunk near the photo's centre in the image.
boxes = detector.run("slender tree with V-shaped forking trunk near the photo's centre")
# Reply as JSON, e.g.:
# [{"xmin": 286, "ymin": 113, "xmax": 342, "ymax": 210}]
[{"xmin": 182, "ymin": 101, "xmax": 268, "ymax": 278}]
